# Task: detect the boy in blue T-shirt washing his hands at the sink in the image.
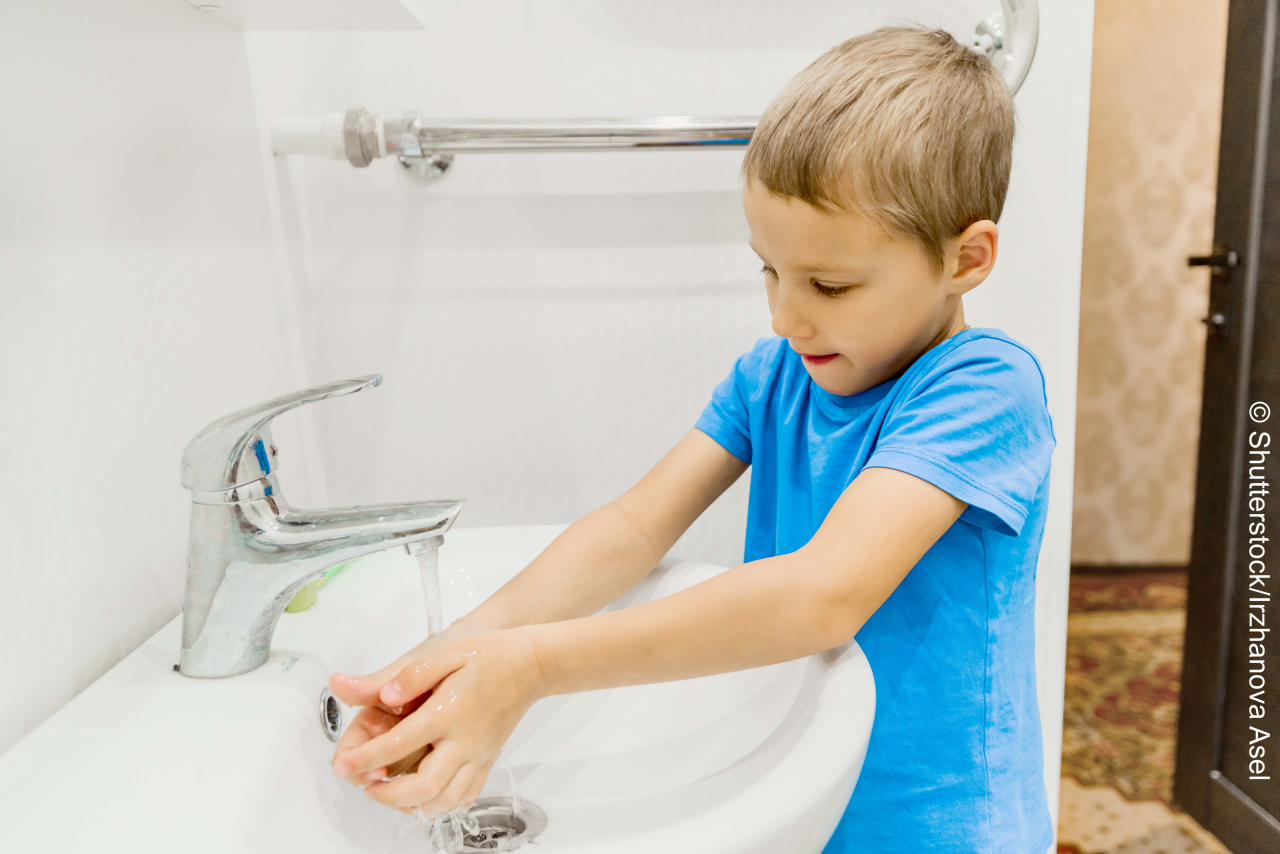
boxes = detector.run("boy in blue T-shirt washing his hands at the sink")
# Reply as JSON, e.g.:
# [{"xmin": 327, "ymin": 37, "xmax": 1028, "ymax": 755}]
[{"xmin": 332, "ymin": 27, "xmax": 1053, "ymax": 854}]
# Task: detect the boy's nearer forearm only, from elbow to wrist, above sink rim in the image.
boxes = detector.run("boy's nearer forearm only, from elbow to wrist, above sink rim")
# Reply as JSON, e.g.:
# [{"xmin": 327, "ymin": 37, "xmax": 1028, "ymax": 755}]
[{"xmin": 521, "ymin": 552, "xmax": 874, "ymax": 694}]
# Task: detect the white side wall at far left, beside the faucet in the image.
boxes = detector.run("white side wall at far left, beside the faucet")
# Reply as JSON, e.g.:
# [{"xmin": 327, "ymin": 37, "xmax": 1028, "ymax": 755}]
[{"xmin": 0, "ymin": 0, "xmax": 296, "ymax": 750}]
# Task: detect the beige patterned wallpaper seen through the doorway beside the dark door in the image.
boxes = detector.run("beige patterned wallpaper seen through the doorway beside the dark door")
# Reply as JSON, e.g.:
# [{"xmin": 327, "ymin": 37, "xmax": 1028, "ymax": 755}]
[{"xmin": 1070, "ymin": 0, "xmax": 1228, "ymax": 563}]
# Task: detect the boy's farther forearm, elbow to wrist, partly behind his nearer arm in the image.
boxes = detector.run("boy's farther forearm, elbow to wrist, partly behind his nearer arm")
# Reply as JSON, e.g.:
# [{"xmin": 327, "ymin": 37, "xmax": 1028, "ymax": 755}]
[{"xmin": 458, "ymin": 502, "xmax": 662, "ymax": 629}]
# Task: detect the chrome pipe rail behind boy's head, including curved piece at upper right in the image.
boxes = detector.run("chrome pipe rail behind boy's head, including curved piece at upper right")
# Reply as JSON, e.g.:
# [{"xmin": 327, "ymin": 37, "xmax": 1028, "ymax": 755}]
[{"xmin": 271, "ymin": 0, "xmax": 1039, "ymax": 179}]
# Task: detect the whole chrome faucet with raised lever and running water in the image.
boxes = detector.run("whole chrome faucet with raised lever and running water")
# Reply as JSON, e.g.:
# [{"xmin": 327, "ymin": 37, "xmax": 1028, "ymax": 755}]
[{"xmin": 178, "ymin": 374, "xmax": 463, "ymax": 677}]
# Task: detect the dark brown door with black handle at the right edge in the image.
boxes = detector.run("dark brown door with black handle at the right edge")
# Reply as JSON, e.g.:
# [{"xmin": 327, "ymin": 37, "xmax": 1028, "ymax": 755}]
[{"xmin": 1170, "ymin": 0, "xmax": 1280, "ymax": 854}]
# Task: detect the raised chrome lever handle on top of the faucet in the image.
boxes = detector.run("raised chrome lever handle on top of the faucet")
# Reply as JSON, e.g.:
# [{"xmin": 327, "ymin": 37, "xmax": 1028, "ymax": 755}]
[{"xmin": 182, "ymin": 374, "xmax": 383, "ymax": 492}]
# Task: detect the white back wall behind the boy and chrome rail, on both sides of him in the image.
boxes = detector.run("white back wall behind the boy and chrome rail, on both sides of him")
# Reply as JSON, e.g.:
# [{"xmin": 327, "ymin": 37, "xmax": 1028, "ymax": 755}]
[{"xmin": 247, "ymin": 0, "xmax": 1092, "ymax": 845}]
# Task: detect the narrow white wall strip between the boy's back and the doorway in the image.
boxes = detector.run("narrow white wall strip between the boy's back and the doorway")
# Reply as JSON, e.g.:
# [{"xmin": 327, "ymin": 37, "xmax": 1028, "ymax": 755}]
[{"xmin": 966, "ymin": 0, "xmax": 1093, "ymax": 850}]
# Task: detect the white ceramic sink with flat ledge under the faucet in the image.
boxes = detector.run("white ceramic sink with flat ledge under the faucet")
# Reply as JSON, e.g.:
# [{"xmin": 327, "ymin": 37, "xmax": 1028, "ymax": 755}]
[{"xmin": 0, "ymin": 525, "xmax": 876, "ymax": 854}]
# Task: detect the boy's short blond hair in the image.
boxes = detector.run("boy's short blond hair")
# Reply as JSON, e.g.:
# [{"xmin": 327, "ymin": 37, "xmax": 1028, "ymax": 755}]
[{"xmin": 742, "ymin": 27, "xmax": 1014, "ymax": 269}]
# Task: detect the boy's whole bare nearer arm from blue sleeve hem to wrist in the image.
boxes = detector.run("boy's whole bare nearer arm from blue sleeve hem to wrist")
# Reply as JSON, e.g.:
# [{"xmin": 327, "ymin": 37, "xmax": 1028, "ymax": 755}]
[{"xmin": 517, "ymin": 467, "xmax": 966, "ymax": 694}]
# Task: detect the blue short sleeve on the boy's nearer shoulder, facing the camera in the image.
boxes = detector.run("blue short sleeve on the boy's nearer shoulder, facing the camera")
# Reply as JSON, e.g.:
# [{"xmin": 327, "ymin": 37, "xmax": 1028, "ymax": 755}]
[{"xmin": 865, "ymin": 338, "xmax": 1055, "ymax": 536}]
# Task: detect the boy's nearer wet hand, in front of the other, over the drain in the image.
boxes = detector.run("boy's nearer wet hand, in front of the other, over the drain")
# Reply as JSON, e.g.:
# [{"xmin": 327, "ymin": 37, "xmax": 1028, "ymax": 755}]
[{"xmin": 333, "ymin": 629, "xmax": 544, "ymax": 816}]
